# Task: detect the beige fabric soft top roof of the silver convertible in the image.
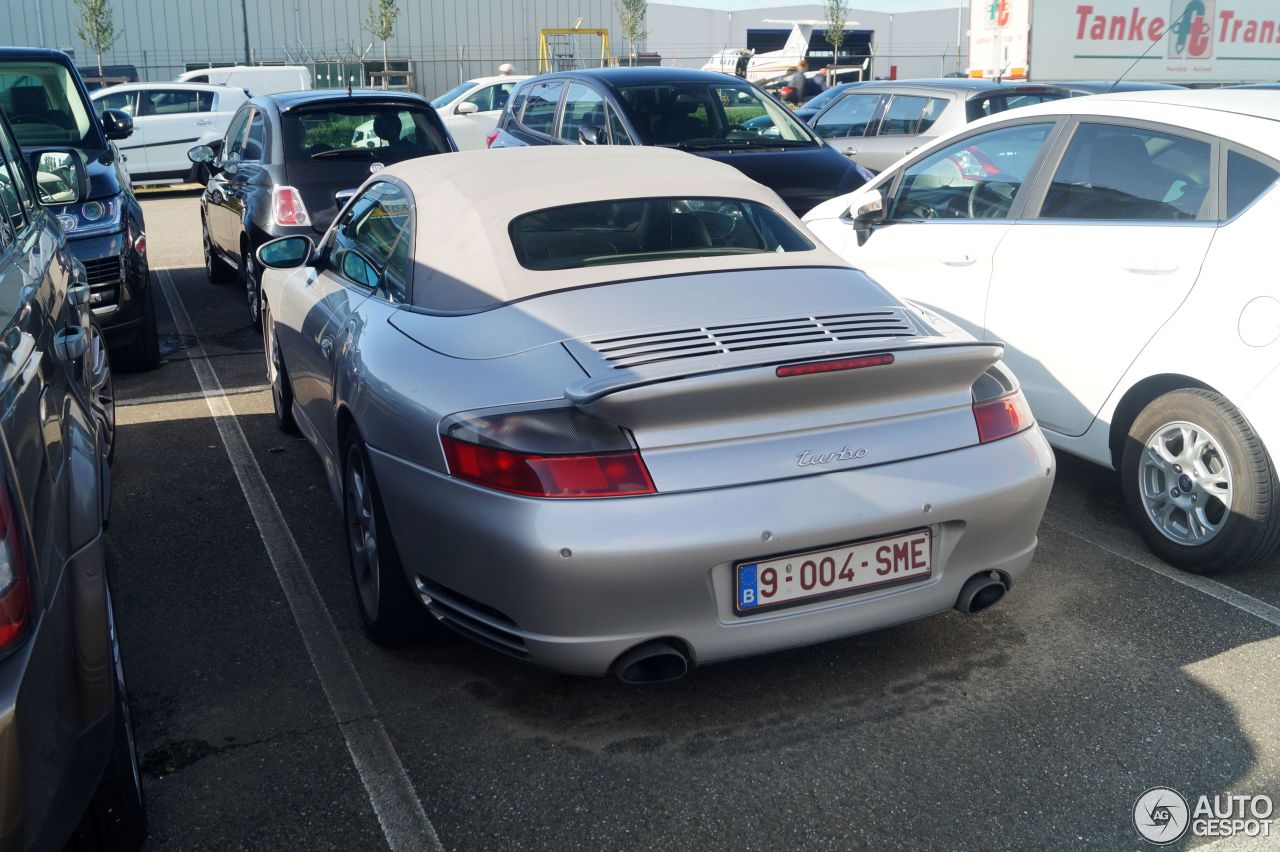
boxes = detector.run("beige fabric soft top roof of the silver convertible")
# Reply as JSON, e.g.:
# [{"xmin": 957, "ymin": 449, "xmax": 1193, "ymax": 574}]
[{"xmin": 380, "ymin": 145, "xmax": 844, "ymax": 311}]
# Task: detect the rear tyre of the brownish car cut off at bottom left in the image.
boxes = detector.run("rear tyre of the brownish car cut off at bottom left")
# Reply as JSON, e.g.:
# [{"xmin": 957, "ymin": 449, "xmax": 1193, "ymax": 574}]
[{"xmin": 68, "ymin": 594, "xmax": 147, "ymax": 852}]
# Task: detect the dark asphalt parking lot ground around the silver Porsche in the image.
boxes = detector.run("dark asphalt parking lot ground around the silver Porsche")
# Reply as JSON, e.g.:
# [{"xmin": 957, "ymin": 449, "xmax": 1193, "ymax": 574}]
[{"xmin": 109, "ymin": 192, "xmax": 1280, "ymax": 849}]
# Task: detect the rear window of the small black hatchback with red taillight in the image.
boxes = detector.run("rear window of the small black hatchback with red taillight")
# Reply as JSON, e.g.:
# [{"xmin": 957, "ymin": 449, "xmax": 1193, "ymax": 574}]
[{"xmin": 282, "ymin": 104, "xmax": 449, "ymax": 162}]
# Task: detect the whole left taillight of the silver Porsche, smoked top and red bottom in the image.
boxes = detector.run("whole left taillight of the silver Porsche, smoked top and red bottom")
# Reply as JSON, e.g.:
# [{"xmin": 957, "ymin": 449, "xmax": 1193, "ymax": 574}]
[{"xmin": 440, "ymin": 408, "xmax": 655, "ymax": 498}]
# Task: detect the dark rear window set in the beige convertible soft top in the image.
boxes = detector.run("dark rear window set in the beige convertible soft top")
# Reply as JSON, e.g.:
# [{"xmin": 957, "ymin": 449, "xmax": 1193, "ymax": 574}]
[{"xmin": 511, "ymin": 198, "xmax": 813, "ymax": 270}]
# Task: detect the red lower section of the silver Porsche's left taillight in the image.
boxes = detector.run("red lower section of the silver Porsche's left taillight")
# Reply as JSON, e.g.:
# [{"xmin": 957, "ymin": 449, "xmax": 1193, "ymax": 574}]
[{"xmin": 440, "ymin": 435, "xmax": 654, "ymax": 498}]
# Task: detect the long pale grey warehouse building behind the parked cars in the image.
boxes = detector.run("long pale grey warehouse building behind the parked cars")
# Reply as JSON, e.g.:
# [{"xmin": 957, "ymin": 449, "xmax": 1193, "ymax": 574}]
[{"xmin": 5, "ymin": 0, "xmax": 968, "ymax": 95}]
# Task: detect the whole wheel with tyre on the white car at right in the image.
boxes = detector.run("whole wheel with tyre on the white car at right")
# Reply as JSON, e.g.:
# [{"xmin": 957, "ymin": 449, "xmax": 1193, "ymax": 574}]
[{"xmin": 1121, "ymin": 389, "xmax": 1280, "ymax": 574}]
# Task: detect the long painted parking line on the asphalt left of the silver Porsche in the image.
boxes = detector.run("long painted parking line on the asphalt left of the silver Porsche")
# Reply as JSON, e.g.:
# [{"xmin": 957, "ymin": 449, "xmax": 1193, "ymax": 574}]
[{"xmin": 156, "ymin": 270, "xmax": 443, "ymax": 852}]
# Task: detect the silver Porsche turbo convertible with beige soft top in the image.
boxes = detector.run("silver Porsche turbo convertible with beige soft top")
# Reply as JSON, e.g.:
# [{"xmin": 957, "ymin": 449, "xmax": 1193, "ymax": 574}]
[{"xmin": 259, "ymin": 146, "xmax": 1053, "ymax": 681}]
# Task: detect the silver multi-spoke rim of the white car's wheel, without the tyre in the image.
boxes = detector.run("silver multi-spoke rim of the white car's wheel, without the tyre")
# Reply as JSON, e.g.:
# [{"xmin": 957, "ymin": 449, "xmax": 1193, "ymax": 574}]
[{"xmin": 1138, "ymin": 421, "xmax": 1234, "ymax": 546}]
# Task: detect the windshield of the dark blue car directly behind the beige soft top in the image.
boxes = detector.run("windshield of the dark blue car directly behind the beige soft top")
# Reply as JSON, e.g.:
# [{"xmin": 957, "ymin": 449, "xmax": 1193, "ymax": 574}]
[{"xmin": 618, "ymin": 79, "xmax": 820, "ymax": 151}]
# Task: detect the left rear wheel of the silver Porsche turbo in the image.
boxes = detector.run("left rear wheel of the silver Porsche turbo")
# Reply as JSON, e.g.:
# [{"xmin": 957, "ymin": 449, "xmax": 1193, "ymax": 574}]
[{"xmin": 342, "ymin": 430, "xmax": 426, "ymax": 645}]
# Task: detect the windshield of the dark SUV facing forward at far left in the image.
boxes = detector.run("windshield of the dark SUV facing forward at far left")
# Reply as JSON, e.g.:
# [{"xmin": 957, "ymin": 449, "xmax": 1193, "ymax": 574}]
[{"xmin": 0, "ymin": 61, "xmax": 105, "ymax": 148}]
